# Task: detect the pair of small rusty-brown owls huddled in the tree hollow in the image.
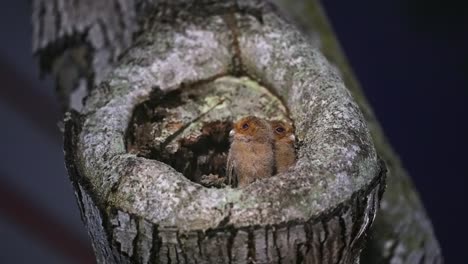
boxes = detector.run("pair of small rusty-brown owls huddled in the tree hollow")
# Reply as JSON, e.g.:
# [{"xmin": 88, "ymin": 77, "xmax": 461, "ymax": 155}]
[{"xmin": 226, "ymin": 116, "xmax": 296, "ymax": 187}]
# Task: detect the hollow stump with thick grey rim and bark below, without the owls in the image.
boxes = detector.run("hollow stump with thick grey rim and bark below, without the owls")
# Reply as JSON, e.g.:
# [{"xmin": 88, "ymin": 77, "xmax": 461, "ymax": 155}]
[{"xmin": 67, "ymin": 3, "xmax": 384, "ymax": 263}]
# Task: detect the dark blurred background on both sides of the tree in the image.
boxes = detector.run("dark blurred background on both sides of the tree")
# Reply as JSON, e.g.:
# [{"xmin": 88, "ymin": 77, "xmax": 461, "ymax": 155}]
[{"xmin": 0, "ymin": 0, "xmax": 468, "ymax": 263}]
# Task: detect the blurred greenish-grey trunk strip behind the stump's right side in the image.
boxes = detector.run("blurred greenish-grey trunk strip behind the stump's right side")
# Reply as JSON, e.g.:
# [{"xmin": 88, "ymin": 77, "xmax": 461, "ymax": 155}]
[{"xmin": 268, "ymin": 0, "xmax": 443, "ymax": 264}]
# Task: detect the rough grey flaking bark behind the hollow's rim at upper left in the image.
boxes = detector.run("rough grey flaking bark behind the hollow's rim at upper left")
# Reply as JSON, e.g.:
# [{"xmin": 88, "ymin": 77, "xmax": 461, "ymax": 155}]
[{"xmin": 32, "ymin": 0, "xmax": 262, "ymax": 111}]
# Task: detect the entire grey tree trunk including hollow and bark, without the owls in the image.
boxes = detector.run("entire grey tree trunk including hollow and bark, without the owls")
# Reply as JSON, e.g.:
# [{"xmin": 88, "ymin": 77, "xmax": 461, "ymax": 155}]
[{"xmin": 33, "ymin": 0, "xmax": 441, "ymax": 263}]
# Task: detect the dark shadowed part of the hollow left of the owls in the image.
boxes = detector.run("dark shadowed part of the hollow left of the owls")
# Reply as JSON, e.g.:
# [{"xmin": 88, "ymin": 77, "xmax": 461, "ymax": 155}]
[{"xmin": 125, "ymin": 86, "xmax": 232, "ymax": 188}]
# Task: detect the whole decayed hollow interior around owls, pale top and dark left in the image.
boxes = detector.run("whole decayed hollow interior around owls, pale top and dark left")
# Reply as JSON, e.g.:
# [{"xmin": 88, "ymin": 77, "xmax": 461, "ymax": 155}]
[{"xmin": 126, "ymin": 76, "xmax": 288, "ymax": 187}]
